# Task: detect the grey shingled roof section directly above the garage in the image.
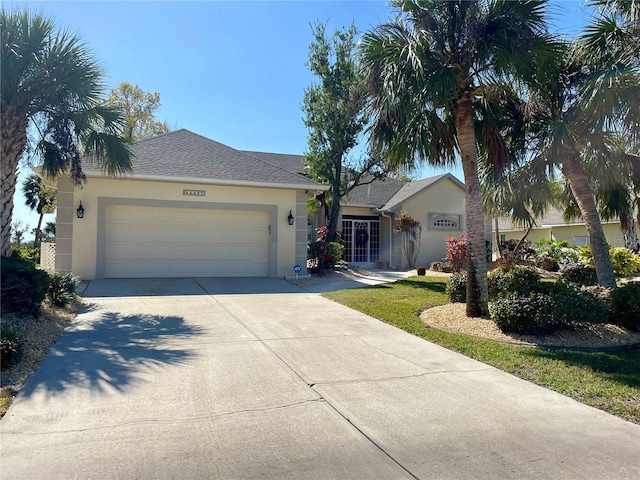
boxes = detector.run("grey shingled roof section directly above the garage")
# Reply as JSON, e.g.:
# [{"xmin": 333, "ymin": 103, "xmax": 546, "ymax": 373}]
[{"xmin": 83, "ymin": 129, "xmax": 327, "ymax": 190}]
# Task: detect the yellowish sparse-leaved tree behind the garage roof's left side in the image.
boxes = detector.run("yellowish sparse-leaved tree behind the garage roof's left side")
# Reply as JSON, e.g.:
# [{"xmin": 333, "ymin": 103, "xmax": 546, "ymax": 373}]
[{"xmin": 108, "ymin": 82, "xmax": 170, "ymax": 141}]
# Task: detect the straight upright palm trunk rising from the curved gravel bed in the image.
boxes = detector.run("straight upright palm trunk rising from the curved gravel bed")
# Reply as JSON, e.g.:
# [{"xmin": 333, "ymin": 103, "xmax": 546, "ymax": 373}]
[{"xmin": 453, "ymin": 93, "xmax": 489, "ymax": 318}]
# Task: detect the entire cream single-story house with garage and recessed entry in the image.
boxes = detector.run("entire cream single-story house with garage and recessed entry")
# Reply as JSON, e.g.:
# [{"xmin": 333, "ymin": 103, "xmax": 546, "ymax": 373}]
[{"xmin": 50, "ymin": 129, "xmax": 465, "ymax": 280}]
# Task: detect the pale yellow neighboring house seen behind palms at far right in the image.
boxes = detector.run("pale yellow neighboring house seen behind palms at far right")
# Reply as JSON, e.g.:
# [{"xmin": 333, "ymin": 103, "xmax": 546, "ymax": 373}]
[{"xmin": 492, "ymin": 208, "xmax": 624, "ymax": 253}]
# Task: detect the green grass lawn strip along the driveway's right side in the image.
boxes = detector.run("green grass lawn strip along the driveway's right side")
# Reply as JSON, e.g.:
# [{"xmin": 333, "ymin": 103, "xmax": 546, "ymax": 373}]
[{"xmin": 323, "ymin": 277, "xmax": 640, "ymax": 424}]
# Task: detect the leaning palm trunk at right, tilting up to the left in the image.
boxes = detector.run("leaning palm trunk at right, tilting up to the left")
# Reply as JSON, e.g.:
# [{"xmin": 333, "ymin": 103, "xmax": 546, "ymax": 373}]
[{"xmin": 562, "ymin": 155, "xmax": 616, "ymax": 288}]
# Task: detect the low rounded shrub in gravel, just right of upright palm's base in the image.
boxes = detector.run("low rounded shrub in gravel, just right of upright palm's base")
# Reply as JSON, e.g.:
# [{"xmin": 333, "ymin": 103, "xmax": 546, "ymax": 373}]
[{"xmin": 489, "ymin": 293, "xmax": 558, "ymax": 335}]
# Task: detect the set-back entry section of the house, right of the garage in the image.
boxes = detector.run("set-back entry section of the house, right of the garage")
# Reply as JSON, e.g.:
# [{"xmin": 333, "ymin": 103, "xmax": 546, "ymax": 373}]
[{"xmin": 251, "ymin": 152, "xmax": 465, "ymax": 269}]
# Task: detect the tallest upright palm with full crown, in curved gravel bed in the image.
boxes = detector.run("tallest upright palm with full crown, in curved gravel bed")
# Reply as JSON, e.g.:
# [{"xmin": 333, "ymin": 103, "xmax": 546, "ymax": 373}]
[{"xmin": 361, "ymin": 0, "xmax": 552, "ymax": 317}]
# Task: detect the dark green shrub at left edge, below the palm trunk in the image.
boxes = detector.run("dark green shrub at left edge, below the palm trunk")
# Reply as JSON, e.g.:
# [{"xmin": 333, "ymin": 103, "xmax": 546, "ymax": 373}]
[{"xmin": 0, "ymin": 255, "xmax": 49, "ymax": 316}]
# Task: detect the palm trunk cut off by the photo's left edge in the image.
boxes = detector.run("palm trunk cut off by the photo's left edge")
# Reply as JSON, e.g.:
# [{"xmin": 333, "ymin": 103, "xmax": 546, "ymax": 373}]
[{"xmin": 0, "ymin": 105, "xmax": 28, "ymax": 256}]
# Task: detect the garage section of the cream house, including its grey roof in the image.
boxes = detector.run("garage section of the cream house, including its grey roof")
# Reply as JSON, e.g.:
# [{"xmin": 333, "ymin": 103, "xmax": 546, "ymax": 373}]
[{"xmin": 50, "ymin": 129, "xmax": 327, "ymax": 279}]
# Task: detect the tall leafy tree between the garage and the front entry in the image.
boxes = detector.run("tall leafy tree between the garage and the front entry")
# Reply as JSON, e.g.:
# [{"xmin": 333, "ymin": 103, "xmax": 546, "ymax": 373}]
[{"xmin": 303, "ymin": 23, "xmax": 384, "ymax": 242}]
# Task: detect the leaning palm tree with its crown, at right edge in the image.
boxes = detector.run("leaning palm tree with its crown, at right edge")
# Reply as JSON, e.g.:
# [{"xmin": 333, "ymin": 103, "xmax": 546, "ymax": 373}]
[{"xmin": 530, "ymin": 15, "xmax": 640, "ymax": 288}]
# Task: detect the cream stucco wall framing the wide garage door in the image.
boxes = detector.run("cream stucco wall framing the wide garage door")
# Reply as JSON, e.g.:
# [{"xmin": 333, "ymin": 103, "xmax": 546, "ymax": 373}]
[{"xmin": 61, "ymin": 178, "xmax": 306, "ymax": 279}]
